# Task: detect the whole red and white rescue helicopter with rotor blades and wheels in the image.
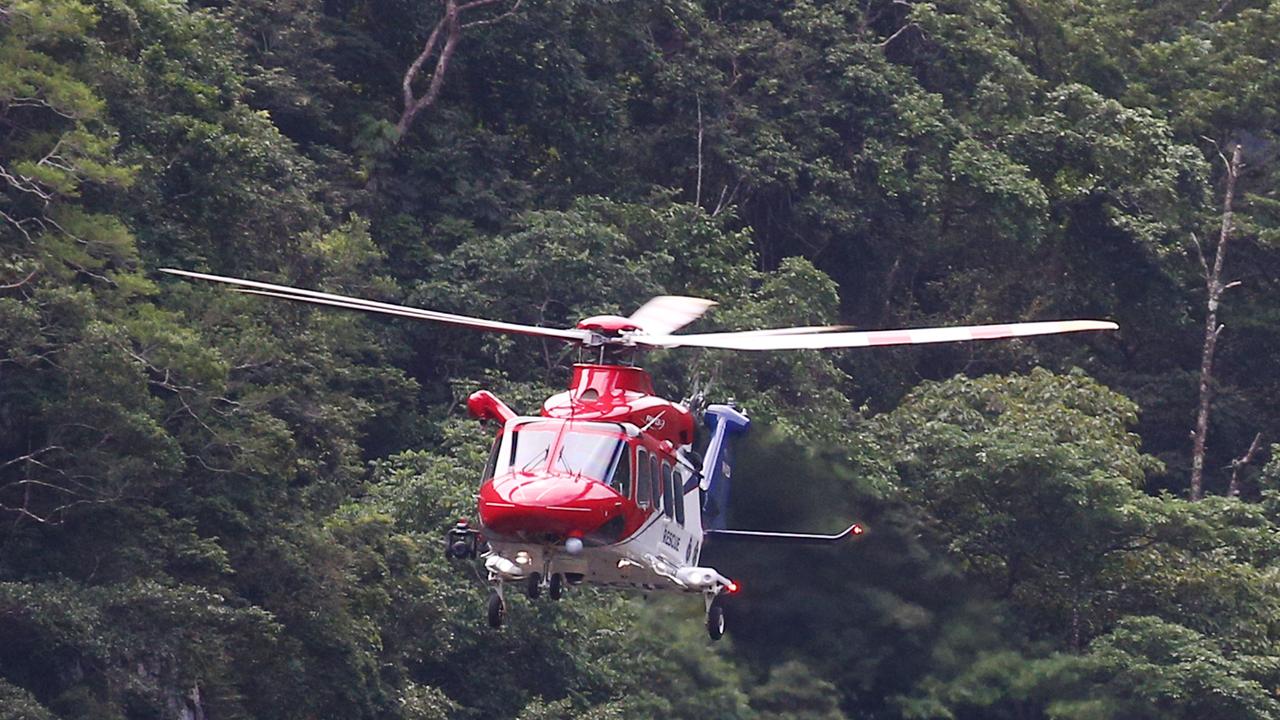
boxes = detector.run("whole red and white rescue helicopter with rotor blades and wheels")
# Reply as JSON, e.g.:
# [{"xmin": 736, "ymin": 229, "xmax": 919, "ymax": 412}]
[{"xmin": 163, "ymin": 269, "xmax": 1116, "ymax": 639}]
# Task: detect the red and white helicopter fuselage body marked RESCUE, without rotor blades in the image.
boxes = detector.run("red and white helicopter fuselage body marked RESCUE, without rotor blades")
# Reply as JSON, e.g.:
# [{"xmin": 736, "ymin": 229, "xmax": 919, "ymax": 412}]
[{"xmin": 472, "ymin": 364, "xmax": 722, "ymax": 592}]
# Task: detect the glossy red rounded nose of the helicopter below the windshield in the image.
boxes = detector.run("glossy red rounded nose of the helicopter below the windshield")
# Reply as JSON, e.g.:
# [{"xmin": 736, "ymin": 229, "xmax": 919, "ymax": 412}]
[{"xmin": 480, "ymin": 473, "xmax": 622, "ymax": 541}]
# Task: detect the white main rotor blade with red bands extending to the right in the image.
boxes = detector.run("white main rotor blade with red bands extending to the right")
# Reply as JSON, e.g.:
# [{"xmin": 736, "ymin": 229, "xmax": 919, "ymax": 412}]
[{"xmin": 634, "ymin": 320, "xmax": 1119, "ymax": 350}]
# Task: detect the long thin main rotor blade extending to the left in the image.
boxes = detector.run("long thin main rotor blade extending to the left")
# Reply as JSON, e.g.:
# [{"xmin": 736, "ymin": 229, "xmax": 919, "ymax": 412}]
[{"xmin": 160, "ymin": 268, "xmax": 590, "ymax": 342}]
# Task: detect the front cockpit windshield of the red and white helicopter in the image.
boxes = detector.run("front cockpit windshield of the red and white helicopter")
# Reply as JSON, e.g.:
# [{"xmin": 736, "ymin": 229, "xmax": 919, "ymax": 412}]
[{"xmin": 494, "ymin": 421, "xmax": 630, "ymax": 483}]
